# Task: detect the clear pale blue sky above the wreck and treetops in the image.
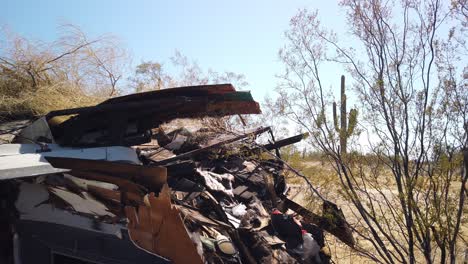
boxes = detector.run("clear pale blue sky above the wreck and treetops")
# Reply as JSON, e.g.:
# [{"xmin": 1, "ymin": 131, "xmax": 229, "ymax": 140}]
[{"xmin": 0, "ymin": 0, "xmax": 344, "ymax": 101}]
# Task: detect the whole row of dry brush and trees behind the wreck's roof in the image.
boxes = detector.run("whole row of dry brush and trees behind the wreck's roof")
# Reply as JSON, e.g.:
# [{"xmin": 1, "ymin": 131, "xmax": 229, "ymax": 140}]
[{"xmin": 0, "ymin": 24, "xmax": 248, "ymax": 121}]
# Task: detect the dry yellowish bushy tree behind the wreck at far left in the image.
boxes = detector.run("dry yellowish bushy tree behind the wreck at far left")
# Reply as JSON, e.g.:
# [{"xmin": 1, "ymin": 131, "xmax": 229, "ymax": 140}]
[{"xmin": 0, "ymin": 25, "xmax": 128, "ymax": 119}]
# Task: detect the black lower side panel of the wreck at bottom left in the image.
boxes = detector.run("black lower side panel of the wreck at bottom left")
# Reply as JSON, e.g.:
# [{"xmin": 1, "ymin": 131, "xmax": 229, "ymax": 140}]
[{"xmin": 16, "ymin": 220, "xmax": 170, "ymax": 264}]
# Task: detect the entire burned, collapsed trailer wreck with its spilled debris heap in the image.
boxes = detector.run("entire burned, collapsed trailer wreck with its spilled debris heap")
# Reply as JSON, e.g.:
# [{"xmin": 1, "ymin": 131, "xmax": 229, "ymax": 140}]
[{"xmin": 0, "ymin": 84, "xmax": 354, "ymax": 263}]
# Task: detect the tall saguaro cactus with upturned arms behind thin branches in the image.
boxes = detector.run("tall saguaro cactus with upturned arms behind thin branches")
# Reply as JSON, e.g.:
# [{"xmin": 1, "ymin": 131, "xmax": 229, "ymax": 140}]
[{"xmin": 333, "ymin": 75, "xmax": 357, "ymax": 153}]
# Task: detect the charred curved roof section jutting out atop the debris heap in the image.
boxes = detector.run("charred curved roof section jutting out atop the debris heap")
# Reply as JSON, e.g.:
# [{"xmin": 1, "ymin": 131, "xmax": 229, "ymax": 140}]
[{"xmin": 47, "ymin": 85, "xmax": 260, "ymax": 146}]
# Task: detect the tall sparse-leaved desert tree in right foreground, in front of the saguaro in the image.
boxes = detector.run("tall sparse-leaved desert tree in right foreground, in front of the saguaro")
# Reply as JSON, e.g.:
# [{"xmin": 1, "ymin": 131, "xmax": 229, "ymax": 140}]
[{"xmin": 272, "ymin": 0, "xmax": 468, "ymax": 263}]
